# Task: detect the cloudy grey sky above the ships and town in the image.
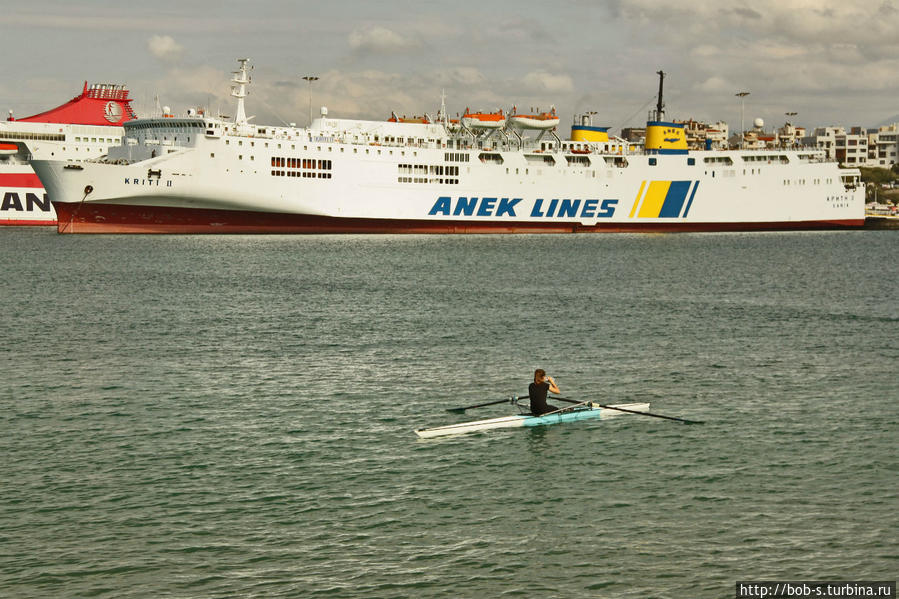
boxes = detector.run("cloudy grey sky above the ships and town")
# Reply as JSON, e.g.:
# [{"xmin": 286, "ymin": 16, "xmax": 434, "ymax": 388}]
[{"xmin": 0, "ymin": 0, "xmax": 899, "ymax": 133}]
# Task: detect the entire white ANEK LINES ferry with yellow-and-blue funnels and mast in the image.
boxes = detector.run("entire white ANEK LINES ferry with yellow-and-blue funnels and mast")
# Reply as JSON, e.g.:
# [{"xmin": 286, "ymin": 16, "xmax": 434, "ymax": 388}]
[{"xmin": 34, "ymin": 59, "xmax": 865, "ymax": 233}]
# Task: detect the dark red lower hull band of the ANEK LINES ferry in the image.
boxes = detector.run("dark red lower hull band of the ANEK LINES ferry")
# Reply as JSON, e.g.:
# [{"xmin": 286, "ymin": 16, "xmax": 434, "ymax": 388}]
[{"xmin": 53, "ymin": 202, "xmax": 864, "ymax": 234}]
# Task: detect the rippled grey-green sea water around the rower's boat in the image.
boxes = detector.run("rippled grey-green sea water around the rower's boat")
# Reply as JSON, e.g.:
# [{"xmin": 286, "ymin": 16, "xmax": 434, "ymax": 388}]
[{"xmin": 0, "ymin": 228, "xmax": 899, "ymax": 599}]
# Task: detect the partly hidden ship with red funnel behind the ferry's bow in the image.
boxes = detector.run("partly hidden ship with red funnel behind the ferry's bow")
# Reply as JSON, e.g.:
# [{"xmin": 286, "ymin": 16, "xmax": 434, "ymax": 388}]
[{"xmin": 0, "ymin": 81, "xmax": 137, "ymax": 226}]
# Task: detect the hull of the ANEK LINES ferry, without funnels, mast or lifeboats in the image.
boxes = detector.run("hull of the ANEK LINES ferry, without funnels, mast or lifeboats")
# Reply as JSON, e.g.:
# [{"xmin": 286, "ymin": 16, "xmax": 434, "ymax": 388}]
[{"xmin": 34, "ymin": 142, "xmax": 864, "ymax": 233}]
